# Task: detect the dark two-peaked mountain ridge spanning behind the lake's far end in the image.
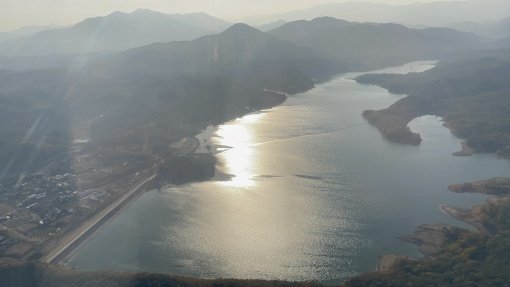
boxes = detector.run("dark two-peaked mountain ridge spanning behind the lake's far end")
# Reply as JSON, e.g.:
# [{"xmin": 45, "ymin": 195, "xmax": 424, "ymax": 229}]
[{"xmin": 85, "ymin": 17, "xmax": 478, "ymax": 82}]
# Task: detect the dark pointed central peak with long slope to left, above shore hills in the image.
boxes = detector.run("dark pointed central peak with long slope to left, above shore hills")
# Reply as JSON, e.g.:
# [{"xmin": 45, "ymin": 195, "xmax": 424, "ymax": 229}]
[{"xmin": 89, "ymin": 24, "xmax": 345, "ymax": 81}]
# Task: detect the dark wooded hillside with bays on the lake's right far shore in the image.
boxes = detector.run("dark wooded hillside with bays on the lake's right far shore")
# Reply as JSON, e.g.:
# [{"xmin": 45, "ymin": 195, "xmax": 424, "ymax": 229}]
[{"xmin": 357, "ymin": 55, "xmax": 510, "ymax": 152}]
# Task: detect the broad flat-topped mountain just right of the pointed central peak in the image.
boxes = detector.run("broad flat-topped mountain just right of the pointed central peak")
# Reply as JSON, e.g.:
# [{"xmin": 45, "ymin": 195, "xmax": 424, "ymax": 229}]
[{"xmin": 268, "ymin": 17, "xmax": 479, "ymax": 70}]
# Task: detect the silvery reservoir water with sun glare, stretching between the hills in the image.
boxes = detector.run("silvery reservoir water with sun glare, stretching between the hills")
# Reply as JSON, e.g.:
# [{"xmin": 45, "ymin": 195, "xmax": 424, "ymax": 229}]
[{"xmin": 69, "ymin": 62, "xmax": 510, "ymax": 282}]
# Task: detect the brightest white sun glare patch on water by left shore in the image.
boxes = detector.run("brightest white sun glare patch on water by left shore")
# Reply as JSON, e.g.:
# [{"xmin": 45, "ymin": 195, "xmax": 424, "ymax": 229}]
[{"xmin": 216, "ymin": 113, "xmax": 264, "ymax": 188}]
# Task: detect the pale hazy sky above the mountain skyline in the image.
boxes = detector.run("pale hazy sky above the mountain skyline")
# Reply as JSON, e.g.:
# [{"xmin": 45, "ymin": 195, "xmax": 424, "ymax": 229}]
[{"xmin": 0, "ymin": 0, "xmax": 466, "ymax": 31}]
